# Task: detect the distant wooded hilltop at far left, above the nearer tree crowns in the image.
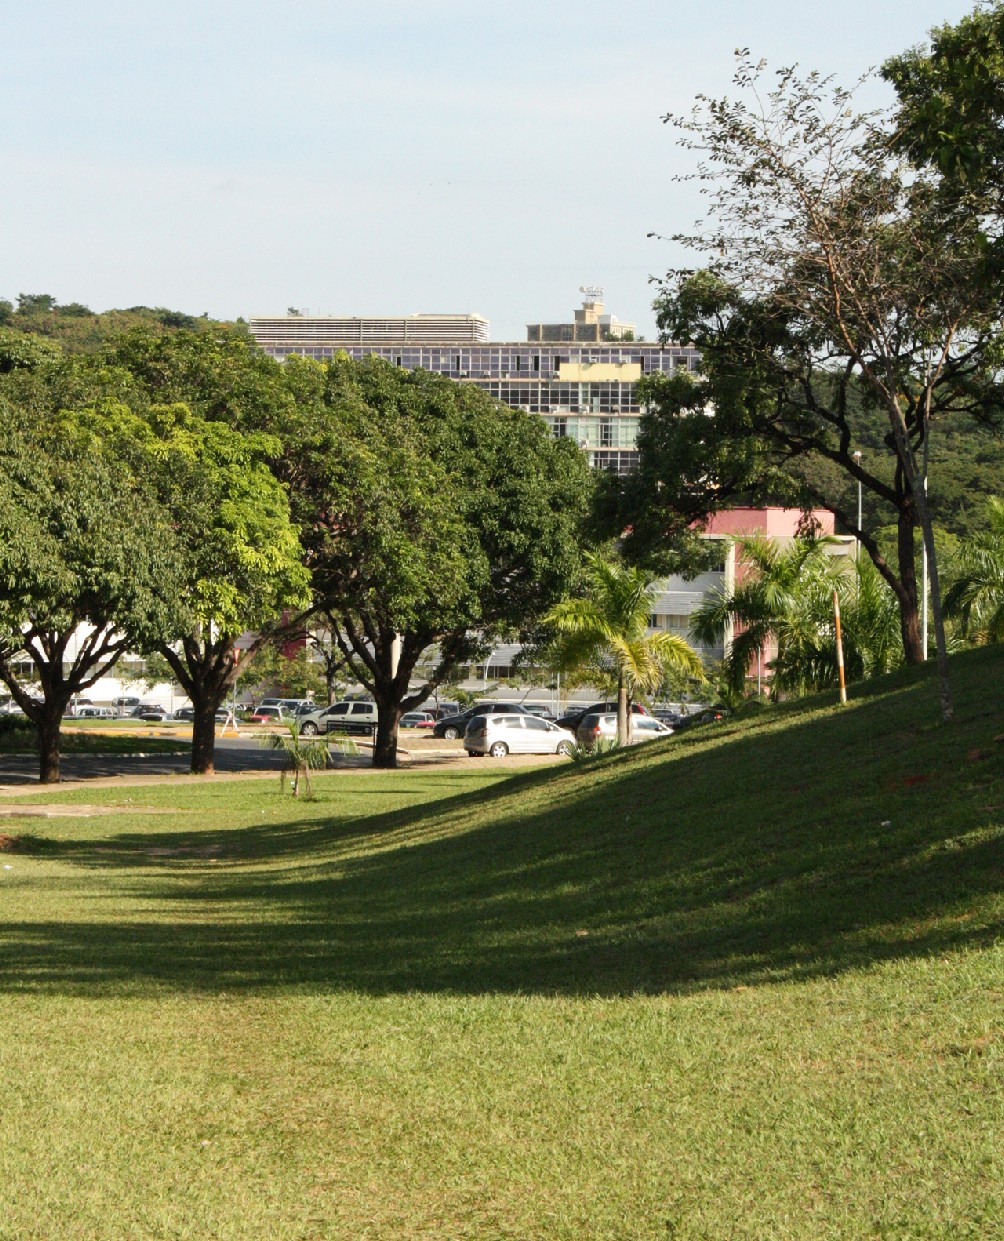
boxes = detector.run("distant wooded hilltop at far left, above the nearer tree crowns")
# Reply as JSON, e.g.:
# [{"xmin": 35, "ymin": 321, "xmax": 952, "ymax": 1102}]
[{"xmin": 0, "ymin": 293, "xmax": 234, "ymax": 354}]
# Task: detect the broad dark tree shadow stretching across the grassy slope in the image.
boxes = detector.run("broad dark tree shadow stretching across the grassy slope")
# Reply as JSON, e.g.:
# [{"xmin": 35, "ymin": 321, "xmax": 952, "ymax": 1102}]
[{"xmin": 0, "ymin": 650, "xmax": 1004, "ymax": 995}]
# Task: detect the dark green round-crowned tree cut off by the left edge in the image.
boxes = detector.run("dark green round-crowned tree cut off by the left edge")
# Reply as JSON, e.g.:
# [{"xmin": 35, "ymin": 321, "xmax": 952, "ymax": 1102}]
[{"xmin": 0, "ymin": 396, "xmax": 180, "ymax": 783}]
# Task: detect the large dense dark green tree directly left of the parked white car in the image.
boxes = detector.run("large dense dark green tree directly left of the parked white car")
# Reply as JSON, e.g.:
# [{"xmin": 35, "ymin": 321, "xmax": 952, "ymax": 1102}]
[{"xmin": 274, "ymin": 356, "xmax": 591, "ymax": 767}]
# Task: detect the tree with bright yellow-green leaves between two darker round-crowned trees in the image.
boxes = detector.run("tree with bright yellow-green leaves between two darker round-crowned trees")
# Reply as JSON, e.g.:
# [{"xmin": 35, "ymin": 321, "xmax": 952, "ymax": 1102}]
[{"xmin": 103, "ymin": 325, "xmax": 310, "ymax": 772}]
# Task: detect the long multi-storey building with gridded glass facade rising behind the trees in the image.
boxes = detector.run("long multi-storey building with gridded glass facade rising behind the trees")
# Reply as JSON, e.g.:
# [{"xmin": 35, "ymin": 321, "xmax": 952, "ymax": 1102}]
[{"xmin": 251, "ymin": 303, "xmax": 697, "ymax": 474}]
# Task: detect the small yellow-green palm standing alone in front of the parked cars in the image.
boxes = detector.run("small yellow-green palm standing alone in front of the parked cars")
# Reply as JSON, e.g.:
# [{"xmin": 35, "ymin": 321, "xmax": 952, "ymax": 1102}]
[{"xmin": 545, "ymin": 552, "xmax": 704, "ymax": 745}]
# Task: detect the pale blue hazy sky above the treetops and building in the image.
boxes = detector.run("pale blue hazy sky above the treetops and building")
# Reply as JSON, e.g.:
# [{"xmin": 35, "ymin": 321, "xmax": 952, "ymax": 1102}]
[{"xmin": 0, "ymin": 0, "xmax": 973, "ymax": 340}]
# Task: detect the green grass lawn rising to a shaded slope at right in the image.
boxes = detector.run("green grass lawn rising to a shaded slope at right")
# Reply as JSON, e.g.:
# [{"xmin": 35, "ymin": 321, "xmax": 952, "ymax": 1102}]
[{"xmin": 0, "ymin": 650, "xmax": 1004, "ymax": 1241}]
